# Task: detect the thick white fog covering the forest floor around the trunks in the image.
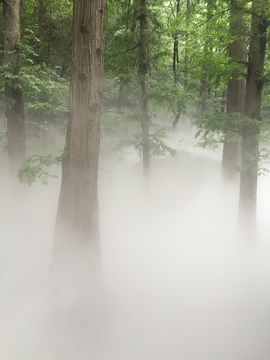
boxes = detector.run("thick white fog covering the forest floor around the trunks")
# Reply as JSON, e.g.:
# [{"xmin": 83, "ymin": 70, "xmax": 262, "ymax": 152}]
[{"xmin": 0, "ymin": 125, "xmax": 270, "ymax": 360}]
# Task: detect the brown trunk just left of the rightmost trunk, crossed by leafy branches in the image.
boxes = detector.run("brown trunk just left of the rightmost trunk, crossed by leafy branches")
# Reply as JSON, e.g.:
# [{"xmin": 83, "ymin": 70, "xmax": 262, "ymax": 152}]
[{"xmin": 222, "ymin": 2, "xmax": 247, "ymax": 180}]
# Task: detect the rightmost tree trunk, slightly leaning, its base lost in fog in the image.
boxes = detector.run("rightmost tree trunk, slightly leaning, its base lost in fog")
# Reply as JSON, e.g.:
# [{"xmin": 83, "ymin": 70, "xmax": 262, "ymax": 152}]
[{"xmin": 239, "ymin": 0, "xmax": 268, "ymax": 224}]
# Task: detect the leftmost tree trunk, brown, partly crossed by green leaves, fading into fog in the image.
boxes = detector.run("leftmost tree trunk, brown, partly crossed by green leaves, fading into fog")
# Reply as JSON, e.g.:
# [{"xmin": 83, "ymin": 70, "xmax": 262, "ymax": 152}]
[{"xmin": 3, "ymin": 0, "xmax": 26, "ymax": 180}]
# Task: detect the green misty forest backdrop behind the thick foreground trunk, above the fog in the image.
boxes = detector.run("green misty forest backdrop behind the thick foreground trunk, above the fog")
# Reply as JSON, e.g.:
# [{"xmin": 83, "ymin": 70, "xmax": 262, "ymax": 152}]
[{"xmin": 0, "ymin": 0, "xmax": 270, "ymax": 225}]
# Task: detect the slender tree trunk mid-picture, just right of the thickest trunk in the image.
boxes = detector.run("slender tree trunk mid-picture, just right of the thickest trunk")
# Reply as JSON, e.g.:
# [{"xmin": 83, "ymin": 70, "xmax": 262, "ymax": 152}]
[{"xmin": 139, "ymin": 0, "xmax": 150, "ymax": 187}]
